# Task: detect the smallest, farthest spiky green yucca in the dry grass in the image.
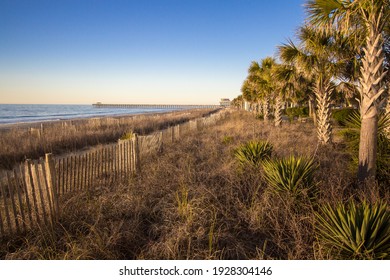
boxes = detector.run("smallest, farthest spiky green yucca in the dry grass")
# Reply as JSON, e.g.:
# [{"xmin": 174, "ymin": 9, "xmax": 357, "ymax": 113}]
[{"xmin": 234, "ymin": 141, "xmax": 273, "ymax": 166}]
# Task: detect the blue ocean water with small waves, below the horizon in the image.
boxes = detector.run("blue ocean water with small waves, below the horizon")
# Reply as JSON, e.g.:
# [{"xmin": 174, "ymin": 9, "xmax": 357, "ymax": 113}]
[{"xmin": 0, "ymin": 104, "xmax": 177, "ymax": 125}]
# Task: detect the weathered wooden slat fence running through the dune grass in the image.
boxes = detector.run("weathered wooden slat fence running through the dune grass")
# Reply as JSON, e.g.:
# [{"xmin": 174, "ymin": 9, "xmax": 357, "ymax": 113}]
[{"xmin": 0, "ymin": 111, "xmax": 226, "ymax": 239}]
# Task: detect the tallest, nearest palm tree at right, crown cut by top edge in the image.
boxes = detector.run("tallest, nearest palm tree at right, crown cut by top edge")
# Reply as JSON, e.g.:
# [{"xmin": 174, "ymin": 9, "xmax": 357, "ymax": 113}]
[{"xmin": 306, "ymin": 0, "xmax": 390, "ymax": 181}]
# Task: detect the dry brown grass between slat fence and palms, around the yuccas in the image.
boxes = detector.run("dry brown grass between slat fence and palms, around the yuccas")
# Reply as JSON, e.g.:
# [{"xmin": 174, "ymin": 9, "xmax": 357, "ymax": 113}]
[{"xmin": 0, "ymin": 112, "xmax": 390, "ymax": 259}]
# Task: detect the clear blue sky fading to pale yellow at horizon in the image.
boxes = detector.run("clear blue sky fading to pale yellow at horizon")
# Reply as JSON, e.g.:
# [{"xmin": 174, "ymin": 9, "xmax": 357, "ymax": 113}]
[{"xmin": 0, "ymin": 0, "xmax": 305, "ymax": 104}]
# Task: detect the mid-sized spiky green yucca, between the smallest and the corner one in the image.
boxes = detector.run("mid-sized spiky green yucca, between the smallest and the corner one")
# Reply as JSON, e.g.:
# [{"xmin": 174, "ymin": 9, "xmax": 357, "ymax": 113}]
[{"xmin": 263, "ymin": 156, "xmax": 317, "ymax": 196}]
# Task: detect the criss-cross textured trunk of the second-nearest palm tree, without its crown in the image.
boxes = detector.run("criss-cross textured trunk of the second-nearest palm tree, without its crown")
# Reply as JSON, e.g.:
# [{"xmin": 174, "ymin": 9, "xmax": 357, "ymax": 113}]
[{"xmin": 313, "ymin": 79, "xmax": 332, "ymax": 145}]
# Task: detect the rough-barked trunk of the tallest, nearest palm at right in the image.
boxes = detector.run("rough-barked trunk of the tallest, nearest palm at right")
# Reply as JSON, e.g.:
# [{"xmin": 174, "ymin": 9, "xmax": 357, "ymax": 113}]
[{"xmin": 358, "ymin": 14, "xmax": 386, "ymax": 181}]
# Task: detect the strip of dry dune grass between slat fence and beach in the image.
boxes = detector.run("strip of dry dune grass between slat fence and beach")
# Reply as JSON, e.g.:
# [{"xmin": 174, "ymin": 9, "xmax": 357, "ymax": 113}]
[{"xmin": 0, "ymin": 106, "xmax": 218, "ymax": 170}]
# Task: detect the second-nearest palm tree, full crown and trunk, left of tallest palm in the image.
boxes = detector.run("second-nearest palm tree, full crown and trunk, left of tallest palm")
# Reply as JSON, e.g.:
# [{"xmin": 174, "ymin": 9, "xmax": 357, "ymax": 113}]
[{"xmin": 279, "ymin": 25, "xmax": 337, "ymax": 144}]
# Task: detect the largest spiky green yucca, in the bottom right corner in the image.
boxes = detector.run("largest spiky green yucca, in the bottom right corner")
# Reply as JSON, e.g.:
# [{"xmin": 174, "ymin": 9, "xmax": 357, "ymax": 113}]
[{"xmin": 316, "ymin": 201, "xmax": 390, "ymax": 259}]
